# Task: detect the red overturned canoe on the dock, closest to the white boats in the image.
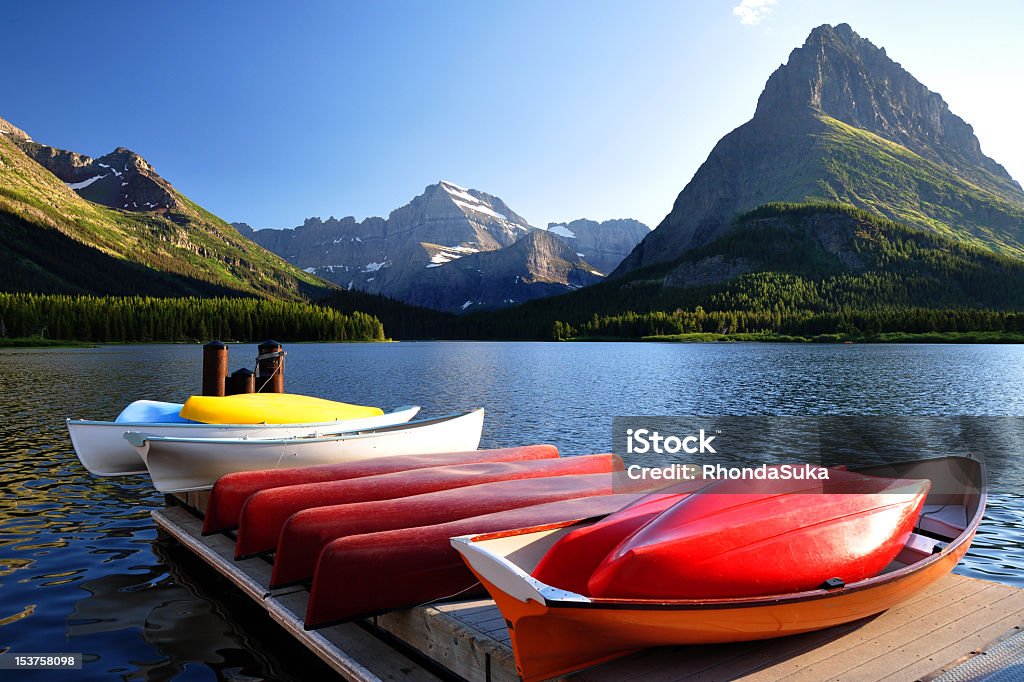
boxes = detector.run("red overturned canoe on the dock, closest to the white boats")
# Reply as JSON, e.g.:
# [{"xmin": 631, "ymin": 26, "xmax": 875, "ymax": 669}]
[{"xmin": 197, "ymin": 445, "xmax": 558, "ymax": 535}]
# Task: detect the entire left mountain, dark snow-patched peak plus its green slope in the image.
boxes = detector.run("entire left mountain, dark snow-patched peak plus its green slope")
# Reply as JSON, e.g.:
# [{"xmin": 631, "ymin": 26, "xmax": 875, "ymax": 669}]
[{"xmin": 0, "ymin": 112, "xmax": 333, "ymax": 299}]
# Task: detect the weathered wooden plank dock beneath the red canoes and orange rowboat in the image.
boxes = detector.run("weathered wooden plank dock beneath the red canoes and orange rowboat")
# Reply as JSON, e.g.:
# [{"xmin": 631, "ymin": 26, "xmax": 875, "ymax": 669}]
[{"xmin": 153, "ymin": 494, "xmax": 1024, "ymax": 682}]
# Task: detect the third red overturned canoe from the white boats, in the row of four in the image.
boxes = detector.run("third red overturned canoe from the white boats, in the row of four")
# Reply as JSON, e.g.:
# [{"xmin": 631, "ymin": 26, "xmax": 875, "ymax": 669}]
[{"xmin": 270, "ymin": 462, "xmax": 641, "ymax": 588}]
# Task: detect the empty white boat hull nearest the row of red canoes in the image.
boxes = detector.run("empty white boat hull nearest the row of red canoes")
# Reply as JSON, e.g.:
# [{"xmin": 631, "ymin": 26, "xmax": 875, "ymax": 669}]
[{"xmin": 125, "ymin": 410, "xmax": 483, "ymax": 493}]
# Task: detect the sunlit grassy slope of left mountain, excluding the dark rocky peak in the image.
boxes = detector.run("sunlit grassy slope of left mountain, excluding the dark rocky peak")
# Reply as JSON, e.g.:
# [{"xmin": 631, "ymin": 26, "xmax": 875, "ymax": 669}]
[{"xmin": 0, "ymin": 134, "xmax": 331, "ymax": 300}]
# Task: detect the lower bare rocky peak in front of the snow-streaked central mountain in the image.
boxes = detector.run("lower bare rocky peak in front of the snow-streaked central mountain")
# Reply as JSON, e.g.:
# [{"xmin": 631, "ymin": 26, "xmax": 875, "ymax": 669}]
[{"xmin": 403, "ymin": 229, "xmax": 603, "ymax": 312}]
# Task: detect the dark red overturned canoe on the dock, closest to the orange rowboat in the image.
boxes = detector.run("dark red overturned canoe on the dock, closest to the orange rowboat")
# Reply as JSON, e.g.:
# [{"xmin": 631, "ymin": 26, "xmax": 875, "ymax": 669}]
[{"xmin": 305, "ymin": 494, "xmax": 638, "ymax": 629}]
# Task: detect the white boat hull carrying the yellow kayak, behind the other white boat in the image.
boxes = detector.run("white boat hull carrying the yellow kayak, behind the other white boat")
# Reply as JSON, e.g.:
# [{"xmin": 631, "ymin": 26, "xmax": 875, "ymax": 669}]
[{"xmin": 68, "ymin": 407, "xmax": 420, "ymax": 476}]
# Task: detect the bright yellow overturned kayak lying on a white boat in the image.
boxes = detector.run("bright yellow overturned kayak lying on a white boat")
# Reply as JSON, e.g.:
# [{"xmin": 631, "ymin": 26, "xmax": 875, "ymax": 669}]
[{"xmin": 180, "ymin": 393, "xmax": 384, "ymax": 424}]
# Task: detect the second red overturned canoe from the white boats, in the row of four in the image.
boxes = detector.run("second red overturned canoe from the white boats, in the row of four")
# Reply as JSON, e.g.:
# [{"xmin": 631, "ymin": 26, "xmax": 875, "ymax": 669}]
[{"xmin": 234, "ymin": 455, "xmax": 616, "ymax": 559}]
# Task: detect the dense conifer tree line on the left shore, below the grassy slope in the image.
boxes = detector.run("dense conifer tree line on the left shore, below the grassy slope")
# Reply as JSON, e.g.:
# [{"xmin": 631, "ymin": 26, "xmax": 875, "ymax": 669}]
[{"xmin": 0, "ymin": 293, "xmax": 385, "ymax": 343}]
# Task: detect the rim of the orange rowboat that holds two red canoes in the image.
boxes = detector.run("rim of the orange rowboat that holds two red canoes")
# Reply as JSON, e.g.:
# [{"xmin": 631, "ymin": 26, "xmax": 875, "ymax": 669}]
[{"xmin": 452, "ymin": 455, "xmax": 988, "ymax": 611}]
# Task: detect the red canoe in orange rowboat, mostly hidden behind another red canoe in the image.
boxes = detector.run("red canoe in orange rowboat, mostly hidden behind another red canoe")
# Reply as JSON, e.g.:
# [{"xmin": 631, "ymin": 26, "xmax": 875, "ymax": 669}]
[{"xmin": 532, "ymin": 480, "xmax": 707, "ymax": 594}]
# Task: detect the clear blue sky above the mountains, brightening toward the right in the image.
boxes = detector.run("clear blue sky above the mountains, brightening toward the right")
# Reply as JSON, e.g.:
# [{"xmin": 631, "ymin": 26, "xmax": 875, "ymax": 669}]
[{"xmin": 0, "ymin": 0, "xmax": 1024, "ymax": 227}]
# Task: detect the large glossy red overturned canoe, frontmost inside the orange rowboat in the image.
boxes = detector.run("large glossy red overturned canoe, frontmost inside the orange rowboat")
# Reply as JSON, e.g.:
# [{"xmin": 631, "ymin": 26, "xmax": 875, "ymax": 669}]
[{"xmin": 588, "ymin": 470, "xmax": 931, "ymax": 599}]
